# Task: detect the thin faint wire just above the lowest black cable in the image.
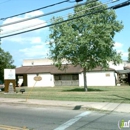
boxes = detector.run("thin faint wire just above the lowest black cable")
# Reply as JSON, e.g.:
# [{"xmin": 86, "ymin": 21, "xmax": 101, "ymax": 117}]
[{"xmin": 2, "ymin": 0, "xmax": 116, "ymax": 35}]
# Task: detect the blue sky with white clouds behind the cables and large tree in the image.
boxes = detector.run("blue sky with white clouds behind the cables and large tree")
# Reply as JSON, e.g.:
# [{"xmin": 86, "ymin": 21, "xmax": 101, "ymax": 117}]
[{"xmin": 0, "ymin": 0, "xmax": 130, "ymax": 67}]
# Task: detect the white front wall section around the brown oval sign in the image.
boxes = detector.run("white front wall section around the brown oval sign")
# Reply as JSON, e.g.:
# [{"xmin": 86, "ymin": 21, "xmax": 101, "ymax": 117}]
[{"xmin": 27, "ymin": 74, "xmax": 54, "ymax": 87}]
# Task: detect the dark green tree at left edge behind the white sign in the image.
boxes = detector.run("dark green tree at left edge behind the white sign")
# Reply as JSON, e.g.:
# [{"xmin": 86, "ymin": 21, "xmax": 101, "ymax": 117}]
[{"xmin": 0, "ymin": 48, "xmax": 15, "ymax": 81}]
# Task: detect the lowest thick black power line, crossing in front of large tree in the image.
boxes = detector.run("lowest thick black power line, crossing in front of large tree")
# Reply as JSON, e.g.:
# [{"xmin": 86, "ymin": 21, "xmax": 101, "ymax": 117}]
[{"xmin": 0, "ymin": 1, "xmax": 125, "ymax": 39}]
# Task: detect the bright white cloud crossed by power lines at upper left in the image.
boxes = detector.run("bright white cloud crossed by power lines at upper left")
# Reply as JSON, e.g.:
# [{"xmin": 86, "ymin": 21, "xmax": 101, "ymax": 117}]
[{"xmin": 1, "ymin": 11, "xmax": 47, "ymax": 35}]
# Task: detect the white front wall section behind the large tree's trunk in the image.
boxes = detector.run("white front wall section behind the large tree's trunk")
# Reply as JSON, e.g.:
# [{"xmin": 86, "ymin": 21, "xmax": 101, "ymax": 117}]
[{"xmin": 79, "ymin": 71, "xmax": 116, "ymax": 86}]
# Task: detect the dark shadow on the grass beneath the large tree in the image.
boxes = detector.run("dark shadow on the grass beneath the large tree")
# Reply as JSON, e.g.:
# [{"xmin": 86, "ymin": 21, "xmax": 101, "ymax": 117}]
[{"xmin": 63, "ymin": 88, "xmax": 106, "ymax": 92}]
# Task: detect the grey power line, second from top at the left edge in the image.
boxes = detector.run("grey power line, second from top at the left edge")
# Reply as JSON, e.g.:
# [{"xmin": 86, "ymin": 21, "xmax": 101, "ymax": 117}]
[{"xmin": 0, "ymin": 0, "xmax": 97, "ymax": 27}]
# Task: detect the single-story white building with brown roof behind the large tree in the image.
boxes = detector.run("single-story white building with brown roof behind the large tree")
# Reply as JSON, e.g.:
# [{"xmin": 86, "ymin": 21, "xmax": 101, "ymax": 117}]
[{"xmin": 16, "ymin": 64, "xmax": 116, "ymax": 87}]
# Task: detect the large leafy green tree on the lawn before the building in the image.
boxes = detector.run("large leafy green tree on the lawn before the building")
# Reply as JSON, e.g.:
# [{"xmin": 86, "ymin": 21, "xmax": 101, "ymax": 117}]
[{"xmin": 50, "ymin": 0, "xmax": 123, "ymax": 91}]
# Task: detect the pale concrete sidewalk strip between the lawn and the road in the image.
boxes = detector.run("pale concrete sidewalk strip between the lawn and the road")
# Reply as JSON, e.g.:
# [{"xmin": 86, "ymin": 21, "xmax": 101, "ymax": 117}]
[{"xmin": 0, "ymin": 98, "xmax": 130, "ymax": 113}]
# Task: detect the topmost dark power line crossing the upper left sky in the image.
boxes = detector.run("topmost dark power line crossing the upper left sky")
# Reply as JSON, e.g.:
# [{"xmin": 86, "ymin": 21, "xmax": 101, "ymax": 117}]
[{"xmin": 0, "ymin": 0, "xmax": 69, "ymax": 20}]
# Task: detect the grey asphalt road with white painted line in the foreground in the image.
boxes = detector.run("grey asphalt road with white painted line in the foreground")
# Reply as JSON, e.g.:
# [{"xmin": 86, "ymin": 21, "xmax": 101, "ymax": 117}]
[{"xmin": 0, "ymin": 104, "xmax": 130, "ymax": 130}]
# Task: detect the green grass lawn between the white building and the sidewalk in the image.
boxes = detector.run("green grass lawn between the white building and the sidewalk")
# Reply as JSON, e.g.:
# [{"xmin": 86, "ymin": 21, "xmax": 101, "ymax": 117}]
[{"xmin": 0, "ymin": 86, "xmax": 130, "ymax": 103}]
